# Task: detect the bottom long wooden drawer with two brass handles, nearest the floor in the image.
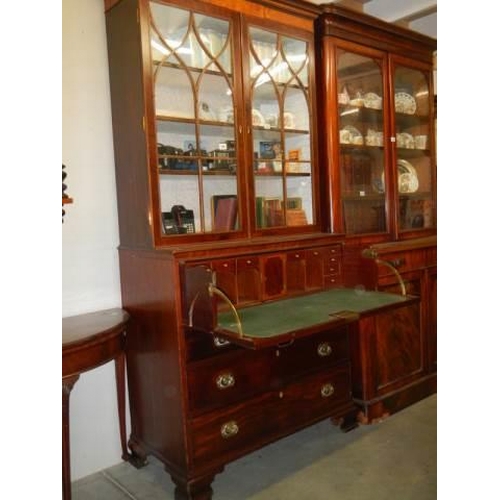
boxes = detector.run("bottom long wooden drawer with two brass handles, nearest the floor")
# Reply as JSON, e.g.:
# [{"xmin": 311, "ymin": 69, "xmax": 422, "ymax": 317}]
[{"xmin": 190, "ymin": 363, "xmax": 351, "ymax": 464}]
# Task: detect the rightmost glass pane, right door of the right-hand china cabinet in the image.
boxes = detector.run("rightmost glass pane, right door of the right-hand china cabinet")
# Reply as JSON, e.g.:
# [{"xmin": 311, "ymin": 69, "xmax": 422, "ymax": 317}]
[{"xmin": 394, "ymin": 66, "xmax": 435, "ymax": 230}]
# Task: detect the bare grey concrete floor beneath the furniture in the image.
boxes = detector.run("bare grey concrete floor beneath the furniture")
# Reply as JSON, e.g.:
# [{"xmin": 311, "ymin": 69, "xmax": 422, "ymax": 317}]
[{"xmin": 72, "ymin": 395, "xmax": 437, "ymax": 500}]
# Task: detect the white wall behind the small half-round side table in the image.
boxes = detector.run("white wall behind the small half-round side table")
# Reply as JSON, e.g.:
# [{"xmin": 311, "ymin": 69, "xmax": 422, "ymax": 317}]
[{"xmin": 62, "ymin": 0, "xmax": 130, "ymax": 480}]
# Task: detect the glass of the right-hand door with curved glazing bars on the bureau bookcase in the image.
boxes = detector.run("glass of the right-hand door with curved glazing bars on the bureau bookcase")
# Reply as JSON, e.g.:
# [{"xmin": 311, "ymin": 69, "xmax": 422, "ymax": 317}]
[{"xmin": 249, "ymin": 27, "xmax": 314, "ymax": 228}]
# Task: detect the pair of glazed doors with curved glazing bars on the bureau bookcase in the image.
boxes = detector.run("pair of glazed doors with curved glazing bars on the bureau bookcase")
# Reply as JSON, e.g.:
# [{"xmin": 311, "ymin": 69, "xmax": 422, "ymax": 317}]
[{"xmin": 146, "ymin": 0, "xmax": 318, "ymax": 244}]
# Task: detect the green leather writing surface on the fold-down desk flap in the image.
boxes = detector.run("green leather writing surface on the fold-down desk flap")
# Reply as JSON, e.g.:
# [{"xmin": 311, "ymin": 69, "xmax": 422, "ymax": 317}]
[{"xmin": 218, "ymin": 288, "xmax": 407, "ymax": 338}]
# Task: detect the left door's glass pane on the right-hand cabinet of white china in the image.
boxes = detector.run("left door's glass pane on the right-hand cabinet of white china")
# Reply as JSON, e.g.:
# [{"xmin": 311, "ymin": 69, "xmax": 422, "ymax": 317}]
[{"xmin": 337, "ymin": 50, "xmax": 386, "ymax": 234}]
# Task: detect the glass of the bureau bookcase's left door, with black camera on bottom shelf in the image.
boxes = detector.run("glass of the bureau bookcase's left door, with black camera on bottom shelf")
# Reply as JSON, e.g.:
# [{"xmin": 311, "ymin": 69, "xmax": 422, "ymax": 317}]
[{"xmin": 150, "ymin": 2, "xmax": 239, "ymax": 234}]
